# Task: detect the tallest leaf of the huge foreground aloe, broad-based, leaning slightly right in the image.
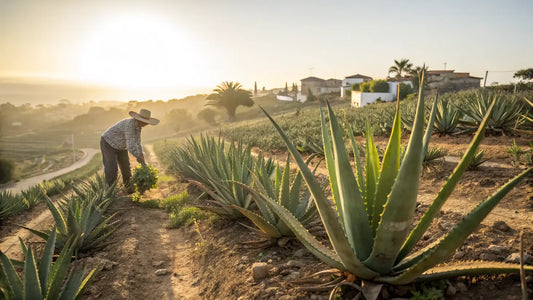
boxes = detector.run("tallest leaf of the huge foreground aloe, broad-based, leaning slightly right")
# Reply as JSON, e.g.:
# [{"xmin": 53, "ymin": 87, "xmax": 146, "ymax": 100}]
[{"xmin": 365, "ymin": 76, "xmax": 424, "ymax": 274}]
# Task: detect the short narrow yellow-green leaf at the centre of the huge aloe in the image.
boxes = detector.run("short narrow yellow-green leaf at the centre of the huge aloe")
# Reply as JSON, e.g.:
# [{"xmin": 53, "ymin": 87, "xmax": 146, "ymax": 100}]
[{"xmin": 365, "ymin": 125, "xmax": 380, "ymax": 220}]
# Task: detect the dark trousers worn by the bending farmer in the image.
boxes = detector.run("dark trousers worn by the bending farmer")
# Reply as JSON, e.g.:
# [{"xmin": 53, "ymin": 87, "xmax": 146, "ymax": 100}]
[{"xmin": 100, "ymin": 137, "xmax": 131, "ymax": 186}]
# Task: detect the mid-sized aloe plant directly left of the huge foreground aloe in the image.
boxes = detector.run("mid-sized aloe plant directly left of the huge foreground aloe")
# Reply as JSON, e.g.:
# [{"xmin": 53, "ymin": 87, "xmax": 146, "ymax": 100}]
[{"xmin": 234, "ymin": 157, "xmax": 318, "ymax": 238}]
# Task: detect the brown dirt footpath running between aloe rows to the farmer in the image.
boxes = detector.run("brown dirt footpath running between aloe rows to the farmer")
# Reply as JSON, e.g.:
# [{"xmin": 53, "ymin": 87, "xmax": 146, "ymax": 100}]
[{"xmin": 85, "ymin": 145, "xmax": 201, "ymax": 299}]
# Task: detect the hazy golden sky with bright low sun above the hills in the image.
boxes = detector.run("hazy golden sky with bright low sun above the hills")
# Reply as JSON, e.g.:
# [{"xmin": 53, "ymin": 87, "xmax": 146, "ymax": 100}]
[{"xmin": 0, "ymin": 0, "xmax": 533, "ymax": 102}]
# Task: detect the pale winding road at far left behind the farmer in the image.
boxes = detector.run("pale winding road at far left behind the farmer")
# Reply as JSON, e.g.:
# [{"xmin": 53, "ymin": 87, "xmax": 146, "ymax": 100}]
[{"xmin": 0, "ymin": 148, "xmax": 100, "ymax": 193}]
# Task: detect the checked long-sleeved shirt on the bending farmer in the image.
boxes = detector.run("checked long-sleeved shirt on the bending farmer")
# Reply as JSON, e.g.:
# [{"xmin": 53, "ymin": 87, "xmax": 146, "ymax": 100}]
[{"xmin": 102, "ymin": 118, "xmax": 143, "ymax": 158}]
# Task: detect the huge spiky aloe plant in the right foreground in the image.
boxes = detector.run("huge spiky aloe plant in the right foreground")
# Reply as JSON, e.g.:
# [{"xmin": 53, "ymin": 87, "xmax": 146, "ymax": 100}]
[{"xmin": 256, "ymin": 74, "xmax": 533, "ymax": 284}]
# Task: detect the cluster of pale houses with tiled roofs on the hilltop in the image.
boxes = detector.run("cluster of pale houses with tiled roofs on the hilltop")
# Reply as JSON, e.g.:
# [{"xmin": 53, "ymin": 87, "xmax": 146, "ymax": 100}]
[{"xmin": 273, "ymin": 70, "xmax": 483, "ymax": 107}]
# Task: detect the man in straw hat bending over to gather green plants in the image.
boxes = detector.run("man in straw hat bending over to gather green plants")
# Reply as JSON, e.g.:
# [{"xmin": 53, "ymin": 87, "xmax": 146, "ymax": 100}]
[{"xmin": 100, "ymin": 109, "xmax": 159, "ymax": 193}]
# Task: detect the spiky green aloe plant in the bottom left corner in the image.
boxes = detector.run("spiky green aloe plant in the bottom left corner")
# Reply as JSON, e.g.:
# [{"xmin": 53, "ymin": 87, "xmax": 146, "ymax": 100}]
[{"xmin": 0, "ymin": 230, "xmax": 96, "ymax": 300}]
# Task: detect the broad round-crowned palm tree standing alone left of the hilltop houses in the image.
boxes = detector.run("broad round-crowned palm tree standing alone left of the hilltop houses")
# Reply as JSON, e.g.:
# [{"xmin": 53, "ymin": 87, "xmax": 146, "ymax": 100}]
[{"xmin": 205, "ymin": 81, "xmax": 254, "ymax": 122}]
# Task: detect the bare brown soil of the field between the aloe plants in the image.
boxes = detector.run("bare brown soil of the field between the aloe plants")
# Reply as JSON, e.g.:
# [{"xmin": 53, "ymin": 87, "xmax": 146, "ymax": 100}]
[{"xmin": 0, "ymin": 89, "xmax": 533, "ymax": 299}]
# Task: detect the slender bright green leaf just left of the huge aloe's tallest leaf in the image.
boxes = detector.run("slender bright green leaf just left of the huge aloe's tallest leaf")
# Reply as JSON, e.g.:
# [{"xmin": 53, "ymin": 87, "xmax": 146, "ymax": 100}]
[{"xmin": 371, "ymin": 98, "xmax": 402, "ymax": 235}]
